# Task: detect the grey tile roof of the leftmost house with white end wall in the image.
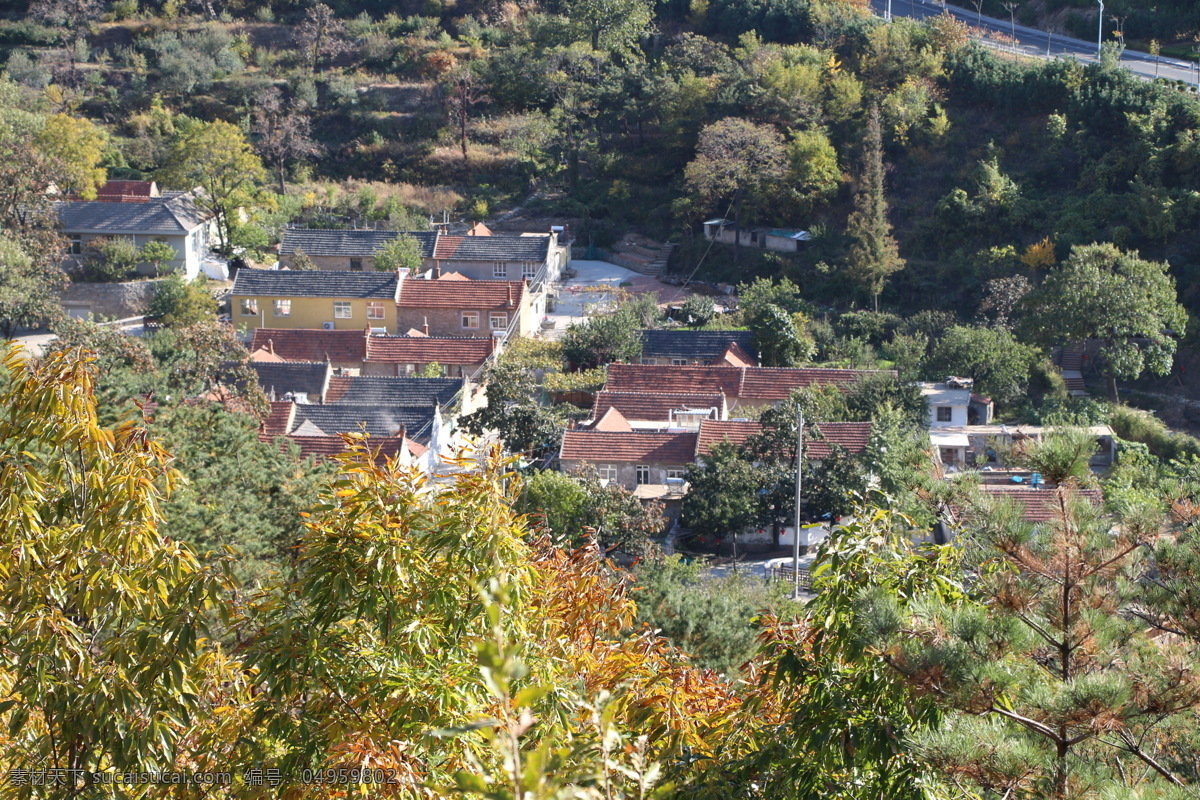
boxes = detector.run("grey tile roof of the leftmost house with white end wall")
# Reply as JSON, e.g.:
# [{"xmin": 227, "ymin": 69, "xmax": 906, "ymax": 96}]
[{"xmin": 56, "ymin": 192, "xmax": 210, "ymax": 236}]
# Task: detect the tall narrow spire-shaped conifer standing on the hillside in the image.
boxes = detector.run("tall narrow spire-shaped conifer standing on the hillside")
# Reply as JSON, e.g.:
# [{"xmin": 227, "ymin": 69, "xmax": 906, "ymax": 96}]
[{"xmin": 846, "ymin": 107, "xmax": 904, "ymax": 311}]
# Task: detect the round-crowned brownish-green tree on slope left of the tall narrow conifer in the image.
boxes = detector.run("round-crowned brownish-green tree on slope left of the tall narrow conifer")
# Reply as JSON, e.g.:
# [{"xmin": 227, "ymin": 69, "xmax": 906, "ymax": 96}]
[{"xmin": 684, "ymin": 116, "xmax": 785, "ymax": 264}]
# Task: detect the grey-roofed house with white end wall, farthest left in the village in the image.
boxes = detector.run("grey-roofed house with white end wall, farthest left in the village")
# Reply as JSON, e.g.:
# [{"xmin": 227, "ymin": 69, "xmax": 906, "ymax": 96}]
[{"xmin": 54, "ymin": 187, "xmax": 218, "ymax": 284}]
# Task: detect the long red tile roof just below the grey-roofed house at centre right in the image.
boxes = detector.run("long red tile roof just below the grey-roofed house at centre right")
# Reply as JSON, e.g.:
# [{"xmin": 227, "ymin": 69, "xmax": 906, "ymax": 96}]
[{"xmin": 605, "ymin": 363, "xmax": 895, "ymax": 403}]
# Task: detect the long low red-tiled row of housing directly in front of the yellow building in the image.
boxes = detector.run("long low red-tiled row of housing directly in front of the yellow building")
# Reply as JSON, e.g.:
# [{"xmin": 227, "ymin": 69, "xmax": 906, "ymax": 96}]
[{"xmin": 250, "ymin": 327, "xmax": 500, "ymax": 378}]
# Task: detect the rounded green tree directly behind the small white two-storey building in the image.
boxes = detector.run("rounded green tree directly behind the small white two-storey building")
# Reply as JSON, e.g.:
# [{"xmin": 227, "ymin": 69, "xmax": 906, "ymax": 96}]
[{"xmin": 925, "ymin": 325, "xmax": 1039, "ymax": 407}]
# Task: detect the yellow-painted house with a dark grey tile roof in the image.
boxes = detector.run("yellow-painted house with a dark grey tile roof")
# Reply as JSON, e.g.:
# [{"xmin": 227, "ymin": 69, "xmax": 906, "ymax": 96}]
[{"xmin": 230, "ymin": 269, "xmax": 398, "ymax": 333}]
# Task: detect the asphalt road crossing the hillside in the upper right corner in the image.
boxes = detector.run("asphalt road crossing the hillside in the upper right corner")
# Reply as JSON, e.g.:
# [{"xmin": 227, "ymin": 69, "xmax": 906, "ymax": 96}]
[{"xmin": 871, "ymin": 0, "xmax": 1200, "ymax": 86}]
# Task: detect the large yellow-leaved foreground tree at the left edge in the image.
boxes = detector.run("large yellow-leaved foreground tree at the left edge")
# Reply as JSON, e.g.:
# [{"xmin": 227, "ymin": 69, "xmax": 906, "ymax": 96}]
[{"xmin": 0, "ymin": 350, "xmax": 236, "ymax": 782}]
